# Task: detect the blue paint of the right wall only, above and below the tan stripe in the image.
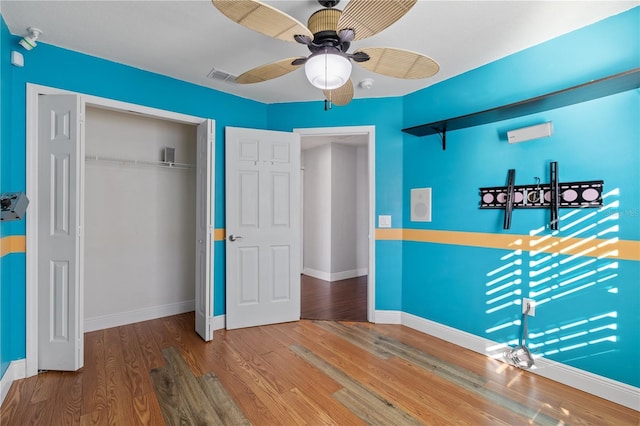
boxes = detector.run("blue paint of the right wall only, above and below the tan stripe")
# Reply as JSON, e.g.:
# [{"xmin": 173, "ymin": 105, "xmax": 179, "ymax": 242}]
[{"xmin": 402, "ymin": 8, "xmax": 640, "ymax": 386}]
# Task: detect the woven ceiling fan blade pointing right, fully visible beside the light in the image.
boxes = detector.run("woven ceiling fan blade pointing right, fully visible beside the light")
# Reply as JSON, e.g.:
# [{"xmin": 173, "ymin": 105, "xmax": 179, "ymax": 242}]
[{"xmin": 354, "ymin": 47, "xmax": 440, "ymax": 79}]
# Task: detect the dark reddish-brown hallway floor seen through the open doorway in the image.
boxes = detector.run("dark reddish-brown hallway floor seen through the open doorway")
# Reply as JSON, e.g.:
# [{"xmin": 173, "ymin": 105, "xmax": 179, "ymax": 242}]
[{"xmin": 300, "ymin": 275, "xmax": 367, "ymax": 321}]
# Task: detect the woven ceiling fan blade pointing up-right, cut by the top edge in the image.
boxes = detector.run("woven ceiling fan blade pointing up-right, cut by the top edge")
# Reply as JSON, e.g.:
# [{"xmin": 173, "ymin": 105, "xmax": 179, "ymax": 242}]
[{"xmin": 338, "ymin": 0, "xmax": 417, "ymax": 40}]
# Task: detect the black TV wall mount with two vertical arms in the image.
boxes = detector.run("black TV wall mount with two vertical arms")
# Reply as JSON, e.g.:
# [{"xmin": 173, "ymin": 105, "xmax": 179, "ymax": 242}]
[{"xmin": 480, "ymin": 161, "xmax": 604, "ymax": 230}]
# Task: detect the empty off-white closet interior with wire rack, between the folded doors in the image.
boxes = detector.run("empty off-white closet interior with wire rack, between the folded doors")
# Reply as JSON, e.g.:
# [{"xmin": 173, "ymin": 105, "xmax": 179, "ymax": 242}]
[{"xmin": 84, "ymin": 105, "xmax": 196, "ymax": 332}]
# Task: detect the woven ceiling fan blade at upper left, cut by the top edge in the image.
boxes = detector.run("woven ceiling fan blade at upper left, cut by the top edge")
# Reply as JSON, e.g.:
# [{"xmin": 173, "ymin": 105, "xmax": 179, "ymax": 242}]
[{"xmin": 211, "ymin": 0, "xmax": 313, "ymax": 42}]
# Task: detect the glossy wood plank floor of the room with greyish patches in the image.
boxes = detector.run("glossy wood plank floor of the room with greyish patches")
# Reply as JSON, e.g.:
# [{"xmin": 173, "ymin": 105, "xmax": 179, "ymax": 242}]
[{"xmin": 0, "ymin": 313, "xmax": 640, "ymax": 426}]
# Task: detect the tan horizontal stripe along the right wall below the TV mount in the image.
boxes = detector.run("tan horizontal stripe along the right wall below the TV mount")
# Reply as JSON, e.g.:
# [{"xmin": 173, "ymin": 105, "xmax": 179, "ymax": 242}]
[{"xmin": 376, "ymin": 229, "xmax": 640, "ymax": 260}]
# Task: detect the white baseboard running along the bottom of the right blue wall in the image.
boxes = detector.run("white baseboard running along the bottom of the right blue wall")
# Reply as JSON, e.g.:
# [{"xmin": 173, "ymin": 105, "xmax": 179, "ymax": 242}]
[{"xmin": 375, "ymin": 311, "xmax": 640, "ymax": 411}]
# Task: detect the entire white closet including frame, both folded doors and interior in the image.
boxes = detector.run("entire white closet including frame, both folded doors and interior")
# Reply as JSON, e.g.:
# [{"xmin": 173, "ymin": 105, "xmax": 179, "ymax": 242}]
[{"xmin": 26, "ymin": 83, "xmax": 215, "ymax": 377}]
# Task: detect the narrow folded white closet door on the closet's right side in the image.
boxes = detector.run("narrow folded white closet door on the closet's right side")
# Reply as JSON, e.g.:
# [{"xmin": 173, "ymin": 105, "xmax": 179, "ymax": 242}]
[{"xmin": 195, "ymin": 120, "xmax": 214, "ymax": 342}]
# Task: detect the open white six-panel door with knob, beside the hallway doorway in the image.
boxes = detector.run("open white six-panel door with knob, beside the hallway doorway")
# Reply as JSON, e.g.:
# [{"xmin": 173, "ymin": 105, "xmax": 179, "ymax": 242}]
[{"xmin": 225, "ymin": 127, "xmax": 300, "ymax": 329}]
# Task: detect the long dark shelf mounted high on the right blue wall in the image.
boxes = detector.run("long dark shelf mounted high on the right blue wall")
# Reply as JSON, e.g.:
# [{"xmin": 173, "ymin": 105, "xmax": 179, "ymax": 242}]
[{"xmin": 402, "ymin": 68, "xmax": 640, "ymax": 149}]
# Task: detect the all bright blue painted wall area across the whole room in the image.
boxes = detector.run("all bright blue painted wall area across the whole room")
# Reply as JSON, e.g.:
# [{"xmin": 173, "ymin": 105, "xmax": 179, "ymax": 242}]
[{"xmin": 0, "ymin": 8, "xmax": 640, "ymax": 386}]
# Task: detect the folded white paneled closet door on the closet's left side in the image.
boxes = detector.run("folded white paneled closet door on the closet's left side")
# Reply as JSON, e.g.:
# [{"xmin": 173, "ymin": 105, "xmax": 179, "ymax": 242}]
[{"xmin": 38, "ymin": 95, "xmax": 84, "ymax": 371}]
